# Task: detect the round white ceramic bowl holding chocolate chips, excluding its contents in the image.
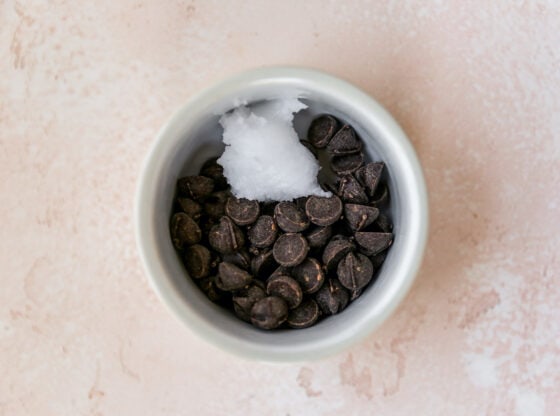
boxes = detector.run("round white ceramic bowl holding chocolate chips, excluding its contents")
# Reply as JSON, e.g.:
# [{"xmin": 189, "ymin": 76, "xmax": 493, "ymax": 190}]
[{"xmin": 135, "ymin": 67, "xmax": 428, "ymax": 361}]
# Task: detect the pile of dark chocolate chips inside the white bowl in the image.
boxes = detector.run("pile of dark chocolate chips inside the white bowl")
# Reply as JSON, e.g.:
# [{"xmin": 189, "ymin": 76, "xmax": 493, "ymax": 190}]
[{"xmin": 170, "ymin": 115, "xmax": 393, "ymax": 329}]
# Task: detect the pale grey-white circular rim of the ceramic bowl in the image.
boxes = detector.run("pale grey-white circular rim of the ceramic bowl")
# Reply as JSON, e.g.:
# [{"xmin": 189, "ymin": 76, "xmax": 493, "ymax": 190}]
[{"xmin": 134, "ymin": 66, "xmax": 429, "ymax": 362}]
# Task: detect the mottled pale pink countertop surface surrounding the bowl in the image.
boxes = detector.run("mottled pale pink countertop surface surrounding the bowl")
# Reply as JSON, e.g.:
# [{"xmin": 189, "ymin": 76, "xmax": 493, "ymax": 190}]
[{"xmin": 0, "ymin": 0, "xmax": 560, "ymax": 416}]
